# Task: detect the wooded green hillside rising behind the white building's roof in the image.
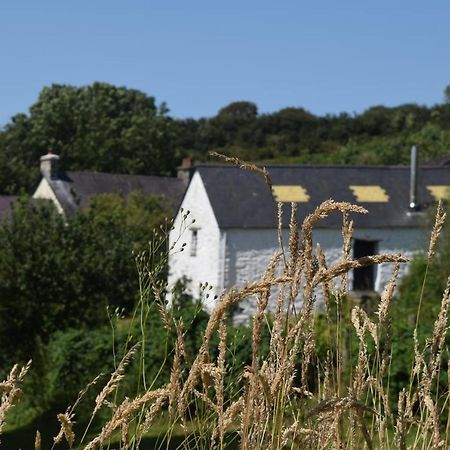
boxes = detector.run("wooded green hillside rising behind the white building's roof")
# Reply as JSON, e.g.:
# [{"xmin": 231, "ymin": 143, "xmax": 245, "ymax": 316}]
[{"xmin": 177, "ymin": 102, "xmax": 450, "ymax": 164}]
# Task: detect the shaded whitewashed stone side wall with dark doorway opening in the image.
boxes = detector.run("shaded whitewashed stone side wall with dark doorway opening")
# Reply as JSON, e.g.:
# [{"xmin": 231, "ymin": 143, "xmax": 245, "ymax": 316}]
[{"xmin": 224, "ymin": 228, "xmax": 427, "ymax": 321}]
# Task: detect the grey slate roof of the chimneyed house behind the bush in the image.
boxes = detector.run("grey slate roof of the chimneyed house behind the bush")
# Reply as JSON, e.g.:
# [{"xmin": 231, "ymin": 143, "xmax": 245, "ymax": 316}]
[{"xmin": 48, "ymin": 172, "xmax": 185, "ymax": 214}]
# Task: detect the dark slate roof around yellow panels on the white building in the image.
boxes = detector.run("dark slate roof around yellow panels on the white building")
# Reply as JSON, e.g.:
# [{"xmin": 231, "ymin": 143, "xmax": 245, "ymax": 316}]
[{"xmin": 196, "ymin": 165, "xmax": 450, "ymax": 228}]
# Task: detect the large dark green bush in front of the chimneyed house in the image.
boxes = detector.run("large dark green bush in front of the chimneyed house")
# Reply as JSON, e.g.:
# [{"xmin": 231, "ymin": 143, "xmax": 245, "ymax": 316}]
[{"xmin": 0, "ymin": 194, "xmax": 166, "ymax": 366}]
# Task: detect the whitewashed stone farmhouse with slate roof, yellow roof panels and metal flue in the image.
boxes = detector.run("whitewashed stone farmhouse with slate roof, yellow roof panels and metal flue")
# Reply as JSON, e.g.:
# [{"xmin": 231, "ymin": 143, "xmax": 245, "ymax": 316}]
[{"xmin": 169, "ymin": 156, "xmax": 450, "ymax": 320}]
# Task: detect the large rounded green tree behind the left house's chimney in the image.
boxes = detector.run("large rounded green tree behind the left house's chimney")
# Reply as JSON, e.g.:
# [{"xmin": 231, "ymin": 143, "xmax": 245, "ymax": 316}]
[{"xmin": 0, "ymin": 83, "xmax": 176, "ymax": 193}]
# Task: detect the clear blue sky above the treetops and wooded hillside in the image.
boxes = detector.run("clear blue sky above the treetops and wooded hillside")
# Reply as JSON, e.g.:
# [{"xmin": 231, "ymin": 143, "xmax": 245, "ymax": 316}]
[{"xmin": 0, "ymin": 0, "xmax": 450, "ymax": 125}]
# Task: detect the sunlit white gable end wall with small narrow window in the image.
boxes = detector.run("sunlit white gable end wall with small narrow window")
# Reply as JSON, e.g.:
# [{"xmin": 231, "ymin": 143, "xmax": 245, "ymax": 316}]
[{"xmin": 168, "ymin": 172, "xmax": 226, "ymax": 308}]
